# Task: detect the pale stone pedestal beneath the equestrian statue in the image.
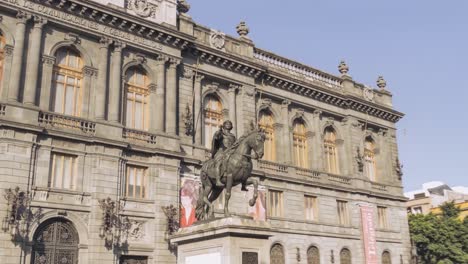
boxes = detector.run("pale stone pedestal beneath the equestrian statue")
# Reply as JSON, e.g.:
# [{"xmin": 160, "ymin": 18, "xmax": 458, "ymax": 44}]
[{"xmin": 170, "ymin": 217, "xmax": 272, "ymax": 264}]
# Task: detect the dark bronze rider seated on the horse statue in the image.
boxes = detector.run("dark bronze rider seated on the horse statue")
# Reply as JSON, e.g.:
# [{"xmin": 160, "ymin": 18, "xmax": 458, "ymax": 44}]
[{"xmin": 211, "ymin": 120, "xmax": 236, "ymax": 187}]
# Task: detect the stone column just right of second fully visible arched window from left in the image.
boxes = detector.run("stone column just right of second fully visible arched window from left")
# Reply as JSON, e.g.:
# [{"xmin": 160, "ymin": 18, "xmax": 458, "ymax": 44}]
[{"xmin": 154, "ymin": 56, "xmax": 166, "ymax": 132}]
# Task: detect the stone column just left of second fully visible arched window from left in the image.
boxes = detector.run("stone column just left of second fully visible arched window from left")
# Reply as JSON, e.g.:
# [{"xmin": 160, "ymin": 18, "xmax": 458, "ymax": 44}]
[{"xmin": 108, "ymin": 41, "xmax": 125, "ymax": 123}]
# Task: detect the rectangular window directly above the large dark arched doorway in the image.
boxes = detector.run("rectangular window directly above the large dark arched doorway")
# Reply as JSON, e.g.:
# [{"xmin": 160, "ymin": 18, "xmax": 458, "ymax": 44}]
[{"xmin": 49, "ymin": 153, "xmax": 76, "ymax": 190}]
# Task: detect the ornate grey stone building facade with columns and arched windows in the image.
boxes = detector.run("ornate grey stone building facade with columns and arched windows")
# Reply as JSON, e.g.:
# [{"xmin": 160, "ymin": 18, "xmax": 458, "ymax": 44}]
[{"xmin": 0, "ymin": 0, "xmax": 410, "ymax": 264}]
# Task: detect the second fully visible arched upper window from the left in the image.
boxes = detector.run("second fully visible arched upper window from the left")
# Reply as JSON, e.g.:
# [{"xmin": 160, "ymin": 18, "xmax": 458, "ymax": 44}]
[{"xmin": 125, "ymin": 67, "xmax": 149, "ymax": 130}]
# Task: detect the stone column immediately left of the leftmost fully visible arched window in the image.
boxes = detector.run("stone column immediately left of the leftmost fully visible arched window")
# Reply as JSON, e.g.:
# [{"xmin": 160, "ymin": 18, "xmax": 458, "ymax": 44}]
[{"xmin": 23, "ymin": 15, "xmax": 47, "ymax": 105}]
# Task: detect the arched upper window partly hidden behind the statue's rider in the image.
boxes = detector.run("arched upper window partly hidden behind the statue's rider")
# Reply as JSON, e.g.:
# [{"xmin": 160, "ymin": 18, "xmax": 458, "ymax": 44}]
[{"xmin": 203, "ymin": 95, "xmax": 223, "ymax": 149}]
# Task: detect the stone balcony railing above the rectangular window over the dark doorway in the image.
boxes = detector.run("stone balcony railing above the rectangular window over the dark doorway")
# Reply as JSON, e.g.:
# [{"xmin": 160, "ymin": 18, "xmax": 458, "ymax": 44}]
[{"xmin": 39, "ymin": 112, "xmax": 96, "ymax": 135}]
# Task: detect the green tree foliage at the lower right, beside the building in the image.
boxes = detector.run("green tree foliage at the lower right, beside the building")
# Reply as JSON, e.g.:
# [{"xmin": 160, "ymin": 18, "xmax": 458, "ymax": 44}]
[{"xmin": 409, "ymin": 202, "xmax": 468, "ymax": 264}]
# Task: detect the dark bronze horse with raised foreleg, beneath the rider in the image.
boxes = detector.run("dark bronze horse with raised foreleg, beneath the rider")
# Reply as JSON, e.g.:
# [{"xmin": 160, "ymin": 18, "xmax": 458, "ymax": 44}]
[{"xmin": 196, "ymin": 129, "xmax": 265, "ymax": 220}]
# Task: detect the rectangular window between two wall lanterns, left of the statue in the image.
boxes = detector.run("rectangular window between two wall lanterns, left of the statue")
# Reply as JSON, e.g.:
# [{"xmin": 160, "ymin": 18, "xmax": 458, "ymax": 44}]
[{"xmin": 125, "ymin": 165, "xmax": 147, "ymax": 199}]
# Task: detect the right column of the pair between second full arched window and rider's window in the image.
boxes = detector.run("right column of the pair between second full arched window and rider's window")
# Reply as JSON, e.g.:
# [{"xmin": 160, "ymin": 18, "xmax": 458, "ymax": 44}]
[{"xmin": 166, "ymin": 59, "xmax": 179, "ymax": 135}]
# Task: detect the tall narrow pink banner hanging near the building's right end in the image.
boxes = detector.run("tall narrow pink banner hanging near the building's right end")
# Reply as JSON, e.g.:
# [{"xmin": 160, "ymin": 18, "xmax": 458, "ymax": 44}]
[{"xmin": 360, "ymin": 205, "xmax": 378, "ymax": 264}]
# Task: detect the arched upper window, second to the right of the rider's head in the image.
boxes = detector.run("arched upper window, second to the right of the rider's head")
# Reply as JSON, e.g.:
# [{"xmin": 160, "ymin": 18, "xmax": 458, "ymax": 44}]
[{"xmin": 293, "ymin": 119, "xmax": 309, "ymax": 168}]
